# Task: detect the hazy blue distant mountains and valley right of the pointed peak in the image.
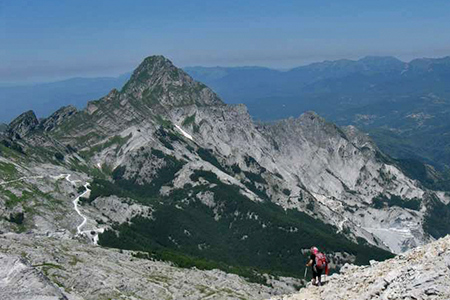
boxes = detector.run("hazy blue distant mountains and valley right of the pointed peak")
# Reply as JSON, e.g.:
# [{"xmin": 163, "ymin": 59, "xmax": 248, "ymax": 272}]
[{"xmin": 185, "ymin": 56, "xmax": 450, "ymax": 169}]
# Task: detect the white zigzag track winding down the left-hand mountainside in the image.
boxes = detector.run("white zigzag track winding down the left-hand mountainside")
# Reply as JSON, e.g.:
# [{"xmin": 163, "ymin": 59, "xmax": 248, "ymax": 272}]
[{"xmin": 0, "ymin": 174, "xmax": 105, "ymax": 244}]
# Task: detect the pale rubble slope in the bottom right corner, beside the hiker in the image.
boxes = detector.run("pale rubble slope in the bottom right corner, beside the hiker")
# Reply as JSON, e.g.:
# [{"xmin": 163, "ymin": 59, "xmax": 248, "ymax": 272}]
[{"xmin": 271, "ymin": 236, "xmax": 450, "ymax": 300}]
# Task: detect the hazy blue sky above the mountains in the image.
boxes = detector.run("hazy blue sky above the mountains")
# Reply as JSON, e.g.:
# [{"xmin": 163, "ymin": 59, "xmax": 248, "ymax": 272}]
[{"xmin": 0, "ymin": 0, "xmax": 450, "ymax": 83}]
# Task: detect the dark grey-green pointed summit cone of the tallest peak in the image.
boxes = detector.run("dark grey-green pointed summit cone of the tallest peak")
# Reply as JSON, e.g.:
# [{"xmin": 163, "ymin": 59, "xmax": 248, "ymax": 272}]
[{"xmin": 121, "ymin": 55, "xmax": 224, "ymax": 107}]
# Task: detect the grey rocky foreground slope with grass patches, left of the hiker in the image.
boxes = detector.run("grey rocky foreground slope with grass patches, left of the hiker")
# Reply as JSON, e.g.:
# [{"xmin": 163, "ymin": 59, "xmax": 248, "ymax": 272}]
[{"xmin": 0, "ymin": 233, "xmax": 299, "ymax": 300}]
